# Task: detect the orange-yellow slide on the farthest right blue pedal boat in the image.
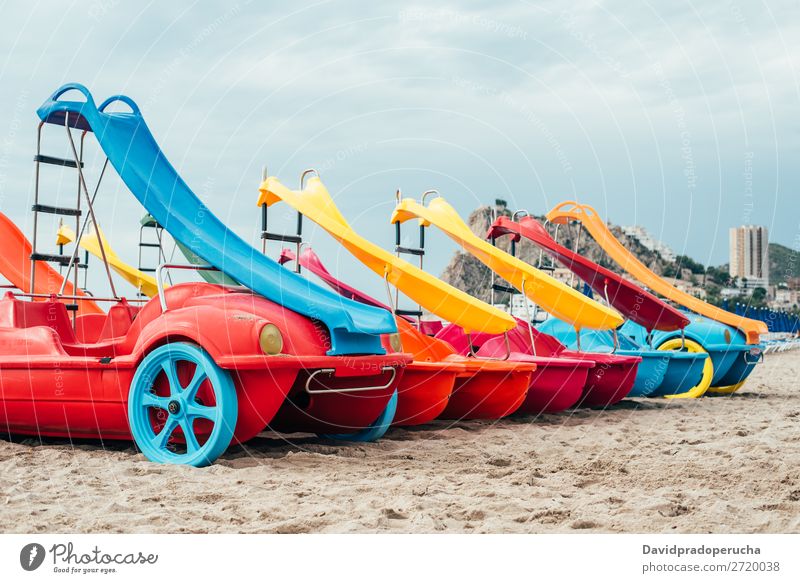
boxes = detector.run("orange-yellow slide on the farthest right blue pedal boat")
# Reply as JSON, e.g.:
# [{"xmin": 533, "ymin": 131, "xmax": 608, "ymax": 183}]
[{"xmin": 547, "ymin": 200, "xmax": 767, "ymax": 344}]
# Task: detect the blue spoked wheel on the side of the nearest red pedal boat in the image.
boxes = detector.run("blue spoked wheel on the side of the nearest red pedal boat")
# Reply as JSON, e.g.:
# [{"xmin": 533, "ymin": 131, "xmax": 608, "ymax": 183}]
[{"xmin": 128, "ymin": 342, "xmax": 239, "ymax": 467}]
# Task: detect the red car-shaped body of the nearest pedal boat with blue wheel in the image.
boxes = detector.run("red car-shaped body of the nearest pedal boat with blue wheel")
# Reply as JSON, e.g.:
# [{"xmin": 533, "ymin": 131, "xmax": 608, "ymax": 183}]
[{"xmin": 0, "ymin": 284, "xmax": 410, "ymax": 442}]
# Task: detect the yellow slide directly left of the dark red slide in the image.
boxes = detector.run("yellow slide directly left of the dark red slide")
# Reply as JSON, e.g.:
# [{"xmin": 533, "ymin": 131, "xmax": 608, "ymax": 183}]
[{"xmin": 391, "ymin": 196, "xmax": 624, "ymax": 330}]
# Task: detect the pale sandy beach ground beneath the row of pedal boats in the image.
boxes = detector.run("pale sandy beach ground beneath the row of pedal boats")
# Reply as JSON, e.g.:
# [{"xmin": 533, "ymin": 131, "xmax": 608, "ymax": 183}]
[{"xmin": 0, "ymin": 352, "xmax": 800, "ymax": 533}]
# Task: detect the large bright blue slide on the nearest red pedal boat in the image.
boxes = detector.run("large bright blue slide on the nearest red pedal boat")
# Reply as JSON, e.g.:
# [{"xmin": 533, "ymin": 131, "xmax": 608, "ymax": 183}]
[{"xmin": 36, "ymin": 83, "xmax": 397, "ymax": 355}]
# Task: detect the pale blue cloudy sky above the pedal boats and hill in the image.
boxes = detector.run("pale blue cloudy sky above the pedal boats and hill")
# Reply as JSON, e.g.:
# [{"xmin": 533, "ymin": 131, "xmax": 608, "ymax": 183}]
[{"xmin": 0, "ymin": 0, "xmax": 800, "ymax": 302}]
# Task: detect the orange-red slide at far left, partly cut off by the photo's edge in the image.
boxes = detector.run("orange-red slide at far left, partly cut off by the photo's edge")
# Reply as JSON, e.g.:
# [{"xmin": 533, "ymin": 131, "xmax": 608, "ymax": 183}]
[{"xmin": 0, "ymin": 213, "xmax": 103, "ymax": 315}]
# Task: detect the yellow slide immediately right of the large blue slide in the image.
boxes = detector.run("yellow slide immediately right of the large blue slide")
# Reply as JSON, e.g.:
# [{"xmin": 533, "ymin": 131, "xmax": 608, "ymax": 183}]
[{"xmin": 258, "ymin": 176, "xmax": 516, "ymax": 334}]
